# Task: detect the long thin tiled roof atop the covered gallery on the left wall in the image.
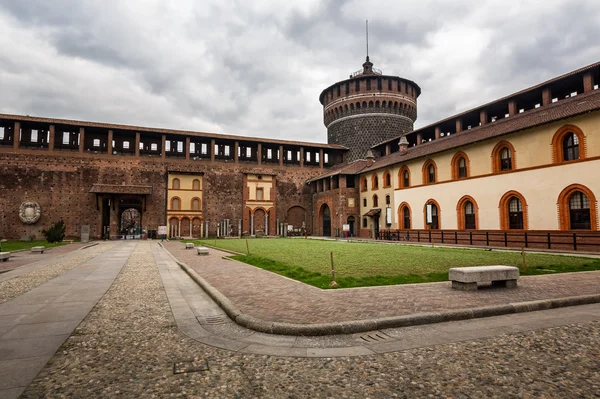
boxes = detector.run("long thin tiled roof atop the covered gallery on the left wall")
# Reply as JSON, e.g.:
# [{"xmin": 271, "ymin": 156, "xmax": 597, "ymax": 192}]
[{"xmin": 0, "ymin": 114, "xmax": 348, "ymax": 150}]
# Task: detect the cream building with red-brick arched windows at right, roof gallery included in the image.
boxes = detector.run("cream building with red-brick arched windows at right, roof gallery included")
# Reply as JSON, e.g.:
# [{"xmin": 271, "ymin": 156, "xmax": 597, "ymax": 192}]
[{"xmin": 360, "ymin": 60, "xmax": 600, "ymax": 240}]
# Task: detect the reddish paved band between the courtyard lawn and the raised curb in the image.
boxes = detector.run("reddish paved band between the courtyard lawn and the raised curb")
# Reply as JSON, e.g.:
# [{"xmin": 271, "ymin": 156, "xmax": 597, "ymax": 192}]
[{"xmin": 164, "ymin": 241, "xmax": 600, "ymax": 324}]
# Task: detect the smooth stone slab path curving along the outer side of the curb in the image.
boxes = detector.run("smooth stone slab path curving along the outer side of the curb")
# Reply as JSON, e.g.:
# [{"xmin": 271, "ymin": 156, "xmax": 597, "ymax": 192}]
[{"xmin": 152, "ymin": 246, "xmax": 600, "ymax": 357}]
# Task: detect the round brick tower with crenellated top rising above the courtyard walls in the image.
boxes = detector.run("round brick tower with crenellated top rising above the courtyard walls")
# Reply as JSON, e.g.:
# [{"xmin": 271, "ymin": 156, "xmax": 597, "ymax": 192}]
[{"xmin": 319, "ymin": 56, "xmax": 421, "ymax": 162}]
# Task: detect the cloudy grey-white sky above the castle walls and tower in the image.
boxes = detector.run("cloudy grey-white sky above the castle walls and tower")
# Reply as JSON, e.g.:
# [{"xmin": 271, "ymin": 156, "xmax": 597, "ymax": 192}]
[{"xmin": 0, "ymin": 0, "xmax": 600, "ymax": 142}]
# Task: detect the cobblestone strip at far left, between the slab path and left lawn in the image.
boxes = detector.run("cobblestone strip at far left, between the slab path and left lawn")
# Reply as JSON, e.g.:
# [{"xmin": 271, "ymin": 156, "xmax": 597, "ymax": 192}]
[{"xmin": 0, "ymin": 243, "xmax": 116, "ymax": 303}]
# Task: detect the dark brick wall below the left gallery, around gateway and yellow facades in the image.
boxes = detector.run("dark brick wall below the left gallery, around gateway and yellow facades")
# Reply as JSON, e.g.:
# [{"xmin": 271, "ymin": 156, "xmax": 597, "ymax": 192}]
[{"xmin": 0, "ymin": 150, "xmax": 323, "ymax": 238}]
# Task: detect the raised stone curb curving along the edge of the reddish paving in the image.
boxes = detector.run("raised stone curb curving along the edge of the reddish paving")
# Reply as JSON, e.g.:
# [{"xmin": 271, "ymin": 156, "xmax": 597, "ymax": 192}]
[{"xmin": 161, "ymin": 245, "xmax": 600, "ymax": 336}]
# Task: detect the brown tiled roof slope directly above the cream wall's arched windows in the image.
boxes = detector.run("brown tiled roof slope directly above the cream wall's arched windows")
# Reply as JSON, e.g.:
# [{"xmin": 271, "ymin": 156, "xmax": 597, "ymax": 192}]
[{"xmin": 362, "ymin": 90, "xmax": 600, "ymax": 172}]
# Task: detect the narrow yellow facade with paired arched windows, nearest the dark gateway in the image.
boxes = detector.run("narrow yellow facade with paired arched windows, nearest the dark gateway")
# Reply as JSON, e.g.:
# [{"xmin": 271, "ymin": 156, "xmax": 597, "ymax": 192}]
[{"xmin": 167, "ymin": 173, "xmax": 204, "ymax": 237}]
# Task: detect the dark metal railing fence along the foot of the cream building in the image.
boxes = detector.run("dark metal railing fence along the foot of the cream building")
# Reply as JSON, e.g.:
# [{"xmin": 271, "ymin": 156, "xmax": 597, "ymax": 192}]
[{"xmin": 375, "ymin": 230, "xmax": 600, "ymax": 252}]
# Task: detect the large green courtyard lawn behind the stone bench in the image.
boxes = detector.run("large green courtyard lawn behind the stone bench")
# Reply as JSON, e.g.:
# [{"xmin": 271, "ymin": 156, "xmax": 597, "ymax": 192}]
[{"xmin": 191, "ymin": 238, "xmax": 600, "ymax": 288}]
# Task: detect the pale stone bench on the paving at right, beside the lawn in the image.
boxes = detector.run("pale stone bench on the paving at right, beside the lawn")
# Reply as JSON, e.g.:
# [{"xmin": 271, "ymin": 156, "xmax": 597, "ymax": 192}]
[{"xmin": 448, "ymin": 266, "xmax": 519, "ymax": 291}]
